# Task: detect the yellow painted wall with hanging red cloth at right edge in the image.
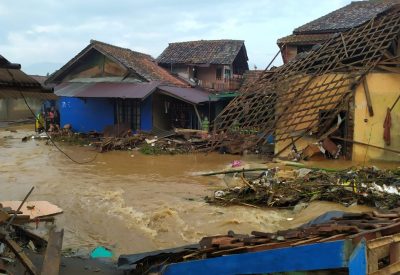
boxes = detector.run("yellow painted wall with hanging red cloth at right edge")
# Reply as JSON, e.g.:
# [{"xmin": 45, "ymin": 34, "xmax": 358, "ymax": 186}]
[{"xmin": 353, "ymin": 73, "xmax": 400, "ymax": 161}]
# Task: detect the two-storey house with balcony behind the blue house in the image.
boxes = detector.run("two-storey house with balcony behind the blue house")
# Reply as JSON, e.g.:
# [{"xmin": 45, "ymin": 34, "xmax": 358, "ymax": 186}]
[{"xmin": 157, "ymin": 39, "xmax": 249, "ymax": 119}]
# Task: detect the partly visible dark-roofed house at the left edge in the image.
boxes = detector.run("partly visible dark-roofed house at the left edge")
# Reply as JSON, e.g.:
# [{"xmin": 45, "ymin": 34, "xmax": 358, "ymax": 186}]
[{"xmin": 0, "ymin": 55, "xmax": 57, "ymax": 121}]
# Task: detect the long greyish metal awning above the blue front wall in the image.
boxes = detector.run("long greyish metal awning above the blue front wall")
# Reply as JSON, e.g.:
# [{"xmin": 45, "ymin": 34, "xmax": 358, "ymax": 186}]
[{"xmin": 55, "ymin": 81, "xmax": 160, "ymax": 99}]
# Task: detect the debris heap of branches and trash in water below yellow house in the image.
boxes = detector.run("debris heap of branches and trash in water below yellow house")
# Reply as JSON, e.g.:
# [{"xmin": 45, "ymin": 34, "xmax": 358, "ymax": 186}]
[{"xmin": 206, "ymin": 167, "xmax": 400, "ymax": 209}]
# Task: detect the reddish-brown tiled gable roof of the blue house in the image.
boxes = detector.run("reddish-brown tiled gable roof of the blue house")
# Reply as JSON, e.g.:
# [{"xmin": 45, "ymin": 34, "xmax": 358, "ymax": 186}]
[{"xmin": 46, "ymin": 40, "xmax": 187, "ymax": 86}]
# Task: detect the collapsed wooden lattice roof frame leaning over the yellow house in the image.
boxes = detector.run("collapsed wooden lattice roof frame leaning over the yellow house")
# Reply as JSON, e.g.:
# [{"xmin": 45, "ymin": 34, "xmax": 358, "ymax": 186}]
[{"xmin": 209, "ymin": 5, "xmax": 400, "ymax": 153}]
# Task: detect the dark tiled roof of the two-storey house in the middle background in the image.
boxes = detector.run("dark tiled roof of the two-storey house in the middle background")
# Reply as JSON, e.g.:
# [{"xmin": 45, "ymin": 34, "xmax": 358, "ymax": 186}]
[{"xmin": 157, "ymin": 40, "xmax": 247, "ymax": 64}]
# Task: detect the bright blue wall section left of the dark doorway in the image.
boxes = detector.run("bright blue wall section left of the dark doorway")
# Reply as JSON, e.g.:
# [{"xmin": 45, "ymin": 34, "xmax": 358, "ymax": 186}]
[{"xmin": 59, "ymin": 97, "xmax": 114, "ymax": 133}]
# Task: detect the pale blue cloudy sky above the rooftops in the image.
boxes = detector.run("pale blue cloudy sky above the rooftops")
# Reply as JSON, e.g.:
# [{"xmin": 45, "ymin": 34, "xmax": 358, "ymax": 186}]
[{"xmin": 0, "ymin": 0, "xmax": 351, "ymax": 75}]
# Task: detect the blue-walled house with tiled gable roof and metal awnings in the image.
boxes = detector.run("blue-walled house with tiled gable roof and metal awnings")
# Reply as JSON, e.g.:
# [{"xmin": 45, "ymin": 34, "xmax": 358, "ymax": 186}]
[{"xmin": 46, "ymin": 40, "xmax": 210, "ymax": 132}]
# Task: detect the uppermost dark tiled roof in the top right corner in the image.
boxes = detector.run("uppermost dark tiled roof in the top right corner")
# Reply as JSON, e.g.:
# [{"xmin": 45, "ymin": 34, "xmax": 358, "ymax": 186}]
[{"xmin": 293, "ymin": 0, "xmax": 400, "ymax": 34}]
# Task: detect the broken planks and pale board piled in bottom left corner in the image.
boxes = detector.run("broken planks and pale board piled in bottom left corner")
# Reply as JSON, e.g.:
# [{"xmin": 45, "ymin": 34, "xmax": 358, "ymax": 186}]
[{"xmin": 0, "ymin": 188, "xmax": 63, "ymax": 275}]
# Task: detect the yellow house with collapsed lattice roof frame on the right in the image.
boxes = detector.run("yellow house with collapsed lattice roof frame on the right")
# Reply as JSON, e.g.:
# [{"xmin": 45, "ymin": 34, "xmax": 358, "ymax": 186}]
[{"xmin": 210, "ymin": 5, "xmax": 400, "ymax": 161}]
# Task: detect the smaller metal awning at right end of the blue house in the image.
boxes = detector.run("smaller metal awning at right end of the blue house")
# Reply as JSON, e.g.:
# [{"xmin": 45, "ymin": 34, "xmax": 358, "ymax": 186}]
[{"xmin": 158, "ymin": 86, "xmax": 210, "ymax": 104}]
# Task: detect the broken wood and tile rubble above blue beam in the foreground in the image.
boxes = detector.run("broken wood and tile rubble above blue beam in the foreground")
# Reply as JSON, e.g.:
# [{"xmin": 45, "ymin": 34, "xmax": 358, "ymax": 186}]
[{"xmin": 118, "ymin": 209, "xmax": 400, "ymax": 274}]
